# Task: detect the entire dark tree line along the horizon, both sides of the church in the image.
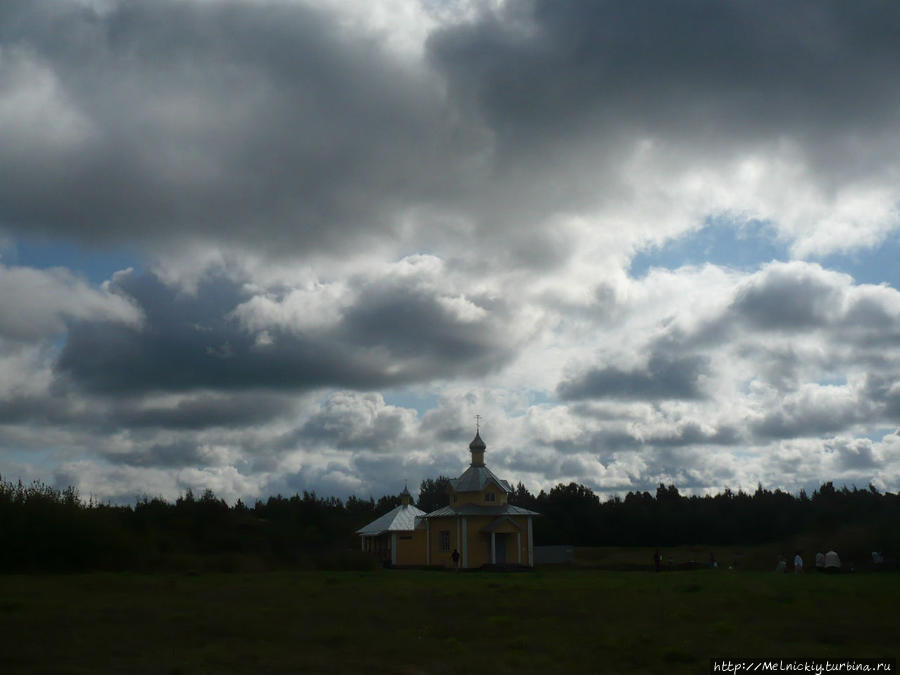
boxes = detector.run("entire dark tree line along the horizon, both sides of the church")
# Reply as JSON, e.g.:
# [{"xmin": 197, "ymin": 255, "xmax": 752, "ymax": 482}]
[{"xmin": 0, "ymin": 476, "xmax": 900, "ymax": 571}]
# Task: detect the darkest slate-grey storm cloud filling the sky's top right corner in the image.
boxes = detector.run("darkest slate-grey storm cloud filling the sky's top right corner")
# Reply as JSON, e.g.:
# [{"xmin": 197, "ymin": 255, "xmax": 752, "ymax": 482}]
[{"xmin": 429, "ymin": 0, "xmax": 900, "ymax": 152}]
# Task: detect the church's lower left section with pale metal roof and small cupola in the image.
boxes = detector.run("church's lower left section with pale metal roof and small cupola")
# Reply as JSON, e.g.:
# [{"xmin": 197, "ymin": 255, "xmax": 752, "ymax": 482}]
[{"xmin": 356, "ymin": 487, "xmax": 425, "ymax": 565}]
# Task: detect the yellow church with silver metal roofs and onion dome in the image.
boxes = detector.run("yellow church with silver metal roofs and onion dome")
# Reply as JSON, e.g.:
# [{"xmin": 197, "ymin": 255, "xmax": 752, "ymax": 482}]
[{"xmin": 357, "ymin": 430, "xmax": 540, "ymax": 569}]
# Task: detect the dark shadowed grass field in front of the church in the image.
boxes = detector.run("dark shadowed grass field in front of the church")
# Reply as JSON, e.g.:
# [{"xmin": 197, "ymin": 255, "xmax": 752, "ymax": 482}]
[{"xmin": 0, "ymin": 569, "xmax": 900, "ymax": 674}]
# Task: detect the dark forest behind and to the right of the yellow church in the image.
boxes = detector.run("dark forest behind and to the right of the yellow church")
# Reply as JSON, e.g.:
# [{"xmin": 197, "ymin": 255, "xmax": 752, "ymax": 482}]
[{"xmin": 419, "ymin": 476, "xmax": 900, "ymax": 553}]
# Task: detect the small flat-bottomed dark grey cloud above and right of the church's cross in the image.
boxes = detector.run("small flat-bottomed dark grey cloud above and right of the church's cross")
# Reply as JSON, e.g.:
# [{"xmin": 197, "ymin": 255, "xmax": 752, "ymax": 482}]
[{"xmin": 556, "ymin": 352, "xmax": 708, "ymax": 400}]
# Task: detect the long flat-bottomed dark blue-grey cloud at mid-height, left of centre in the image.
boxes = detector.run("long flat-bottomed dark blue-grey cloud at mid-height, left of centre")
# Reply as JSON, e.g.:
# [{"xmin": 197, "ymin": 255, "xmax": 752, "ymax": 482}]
[{"xmin": 57, "ymin": 273, "xmax": 513, "ymax": 396}]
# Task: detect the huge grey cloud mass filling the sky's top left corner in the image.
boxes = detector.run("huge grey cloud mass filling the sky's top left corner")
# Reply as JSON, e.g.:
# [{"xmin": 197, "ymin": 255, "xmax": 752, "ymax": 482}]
[{"xmin": 0, "ymin": 0, "xmax": 449, "ymax": 250}]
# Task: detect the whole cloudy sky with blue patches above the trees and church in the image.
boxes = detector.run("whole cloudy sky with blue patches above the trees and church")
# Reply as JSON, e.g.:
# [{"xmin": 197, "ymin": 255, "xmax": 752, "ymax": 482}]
[{"xmin": 0, "ymin": 0, "xmax": 900, "ymax": 503}]
